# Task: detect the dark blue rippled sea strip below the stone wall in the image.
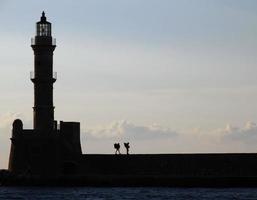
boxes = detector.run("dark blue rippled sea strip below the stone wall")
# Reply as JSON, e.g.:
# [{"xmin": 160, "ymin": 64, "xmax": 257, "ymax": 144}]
[{"xmin": 0, "ymin": 187, "xmax": 257, "ymax": 200}]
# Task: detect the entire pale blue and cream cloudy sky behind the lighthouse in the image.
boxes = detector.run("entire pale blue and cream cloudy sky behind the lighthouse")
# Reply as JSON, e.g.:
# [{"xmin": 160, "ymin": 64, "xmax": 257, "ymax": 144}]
[{"xmin": 0, "ymin": 0, "xmax": 257, "ymax": 168}]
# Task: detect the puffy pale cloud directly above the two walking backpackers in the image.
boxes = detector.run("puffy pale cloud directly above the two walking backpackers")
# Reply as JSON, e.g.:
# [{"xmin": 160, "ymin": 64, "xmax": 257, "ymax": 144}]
[{"xmin": 84, "ymin": 120, "xmax": 177, "ymax": 140}]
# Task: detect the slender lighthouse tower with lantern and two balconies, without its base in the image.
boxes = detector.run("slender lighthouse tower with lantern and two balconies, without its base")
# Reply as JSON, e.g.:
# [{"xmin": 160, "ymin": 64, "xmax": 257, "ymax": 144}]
[{"xmin": 31, "ymin": 12, "xmax": 56, "ymax": 135}]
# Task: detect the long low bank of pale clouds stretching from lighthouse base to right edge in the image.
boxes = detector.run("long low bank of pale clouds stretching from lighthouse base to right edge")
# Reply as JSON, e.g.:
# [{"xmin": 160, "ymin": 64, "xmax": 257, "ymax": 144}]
[{"xmin": 82, "ymin": 120, "xmax": 257, "ymax": 146}]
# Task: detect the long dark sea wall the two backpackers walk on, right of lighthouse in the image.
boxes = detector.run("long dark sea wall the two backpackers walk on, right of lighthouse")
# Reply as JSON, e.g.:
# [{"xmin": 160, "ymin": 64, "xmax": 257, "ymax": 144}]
[{"xmin": 79, "ymin": 153, "xmax": 257, "ymax": 177}]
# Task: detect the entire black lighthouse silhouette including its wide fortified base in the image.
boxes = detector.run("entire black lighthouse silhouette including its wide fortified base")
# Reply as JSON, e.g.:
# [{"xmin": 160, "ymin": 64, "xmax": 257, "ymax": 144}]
[{"xmin": 8, "ymin": 12, "xmax": 82, "ymax": 177}]
